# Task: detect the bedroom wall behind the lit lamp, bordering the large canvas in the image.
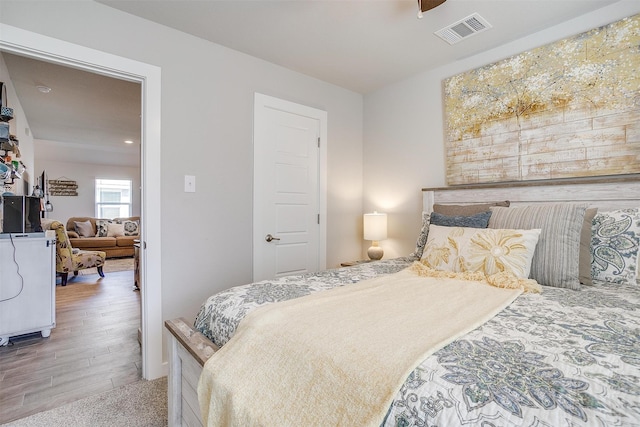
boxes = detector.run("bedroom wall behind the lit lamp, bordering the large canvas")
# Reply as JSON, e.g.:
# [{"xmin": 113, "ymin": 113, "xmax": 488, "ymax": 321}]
[{"xmin": 362, "ymin": 0, "xmax": 640, "ymax": 258}]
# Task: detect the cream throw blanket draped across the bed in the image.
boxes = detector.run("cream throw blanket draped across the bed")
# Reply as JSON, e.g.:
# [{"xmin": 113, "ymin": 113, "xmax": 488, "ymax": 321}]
[{"xmin": 198, "ymin": 269, "xmax": 522, "ymax": 427}]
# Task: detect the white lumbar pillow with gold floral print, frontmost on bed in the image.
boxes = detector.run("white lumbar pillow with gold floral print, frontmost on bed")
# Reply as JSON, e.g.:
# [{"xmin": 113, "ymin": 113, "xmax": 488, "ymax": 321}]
[{"xmin": 421, "ymin": 225, "xmax": 541, "ymax": 279}]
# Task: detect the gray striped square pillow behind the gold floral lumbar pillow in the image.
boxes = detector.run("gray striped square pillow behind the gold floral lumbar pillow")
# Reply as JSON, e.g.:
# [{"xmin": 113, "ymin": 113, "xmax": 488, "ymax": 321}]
[{"xmin": 489, "ymin": 203, "xmax": 587, "ymax": 289}]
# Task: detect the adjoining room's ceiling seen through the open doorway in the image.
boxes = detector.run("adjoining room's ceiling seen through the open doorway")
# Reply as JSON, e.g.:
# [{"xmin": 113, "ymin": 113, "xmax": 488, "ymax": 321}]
[{"xmin": 1, "ymin": 52, "xmax": 141, "ymax": 166}]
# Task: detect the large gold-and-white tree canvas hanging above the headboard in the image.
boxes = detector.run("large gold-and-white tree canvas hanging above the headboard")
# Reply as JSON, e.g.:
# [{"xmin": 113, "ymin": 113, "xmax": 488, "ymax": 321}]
[{"xmin": 444, "ymin": 15, "xmax": 640, "ymax": 185}]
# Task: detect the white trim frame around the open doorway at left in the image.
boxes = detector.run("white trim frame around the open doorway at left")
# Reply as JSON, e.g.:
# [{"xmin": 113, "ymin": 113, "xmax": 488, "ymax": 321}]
[{"xmin": 0, "ymin": 23, "xmax": 168, "ymax": 380}]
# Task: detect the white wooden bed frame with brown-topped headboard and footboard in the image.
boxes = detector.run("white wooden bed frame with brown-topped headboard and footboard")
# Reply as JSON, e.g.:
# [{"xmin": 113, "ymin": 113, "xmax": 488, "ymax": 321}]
[{"xmin": 165, "ymin": 174, "xmax": 640, "ymax": 427}]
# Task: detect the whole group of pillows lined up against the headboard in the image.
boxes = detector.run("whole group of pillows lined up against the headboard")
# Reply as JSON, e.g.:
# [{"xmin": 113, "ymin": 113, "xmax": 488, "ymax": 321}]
[{"xmin": 412, "ymin": 201, "xmax": 640, "ymax": 290}]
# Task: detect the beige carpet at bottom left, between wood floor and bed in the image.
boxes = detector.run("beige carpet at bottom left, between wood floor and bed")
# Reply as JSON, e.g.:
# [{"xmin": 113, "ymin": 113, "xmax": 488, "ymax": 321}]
[{"xmin": 3, "ymin": 377, "xmax": 168, "ymax": 427}]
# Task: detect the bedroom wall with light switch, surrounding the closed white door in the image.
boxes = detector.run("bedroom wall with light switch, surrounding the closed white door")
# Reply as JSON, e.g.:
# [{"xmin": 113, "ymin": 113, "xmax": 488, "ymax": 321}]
[{"xmin": 0, "ymin": 1, "xmax": 362, "ymax": 328}]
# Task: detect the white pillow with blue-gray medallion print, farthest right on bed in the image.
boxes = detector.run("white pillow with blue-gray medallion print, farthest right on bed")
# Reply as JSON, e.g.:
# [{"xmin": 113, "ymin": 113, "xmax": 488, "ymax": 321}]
[{"xmin": 591, "ymin": 209, "xmax": 640, "ymax": 285}]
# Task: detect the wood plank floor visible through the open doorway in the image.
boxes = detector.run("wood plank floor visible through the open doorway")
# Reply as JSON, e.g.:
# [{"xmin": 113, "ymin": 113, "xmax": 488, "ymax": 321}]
[{"xmin": 0, "ymin": 271, "xmax": 142, "ymax": 424}]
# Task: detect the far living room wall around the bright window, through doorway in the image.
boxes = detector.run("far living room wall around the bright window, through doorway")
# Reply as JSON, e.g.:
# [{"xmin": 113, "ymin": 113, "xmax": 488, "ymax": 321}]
[{"xmin": 35, "ymin": 156, "xmax": 140, "ymax": 224}]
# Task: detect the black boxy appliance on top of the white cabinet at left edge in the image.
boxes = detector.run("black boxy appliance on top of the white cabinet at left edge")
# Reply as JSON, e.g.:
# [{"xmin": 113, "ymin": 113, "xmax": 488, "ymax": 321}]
[{"xmin": 2, "ymin": 196, "xmax": 42, "ymax": 233}]
